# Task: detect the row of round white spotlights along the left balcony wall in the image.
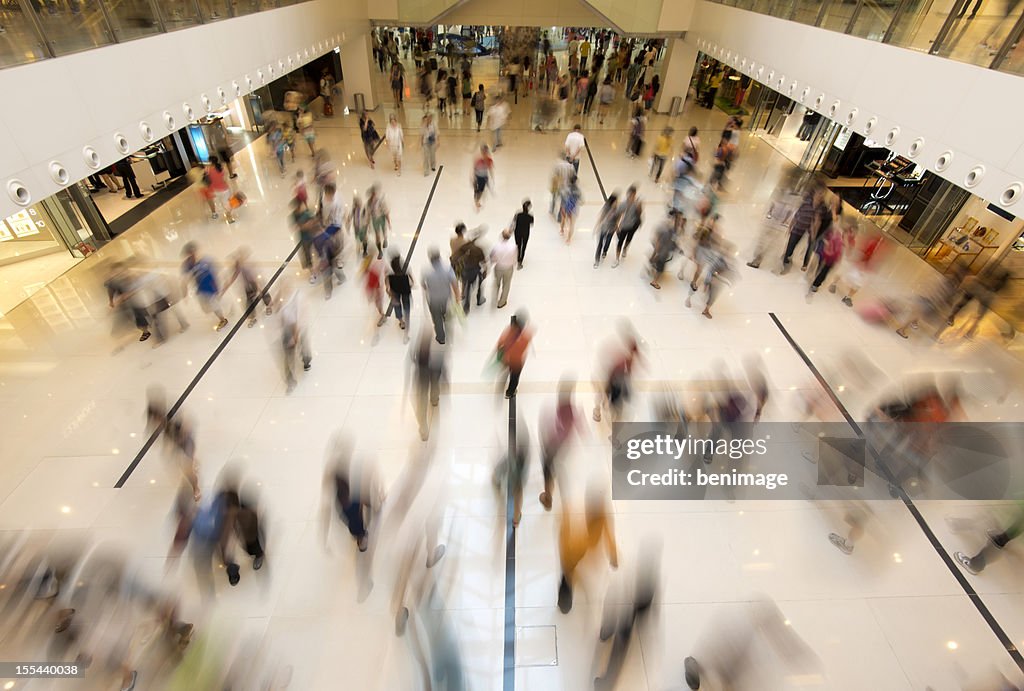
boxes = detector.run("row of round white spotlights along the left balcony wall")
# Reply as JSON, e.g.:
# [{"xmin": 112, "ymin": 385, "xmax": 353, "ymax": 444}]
[{"xmin": 7, "ymin": 34, "xmax": 345, "ymax": 207}]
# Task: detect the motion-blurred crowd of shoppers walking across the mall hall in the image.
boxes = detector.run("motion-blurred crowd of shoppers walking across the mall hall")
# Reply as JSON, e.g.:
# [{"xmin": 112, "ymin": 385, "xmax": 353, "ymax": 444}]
[{"xmin": 48, "ymin": 20, "xmax": 1024, "ymax": 690}]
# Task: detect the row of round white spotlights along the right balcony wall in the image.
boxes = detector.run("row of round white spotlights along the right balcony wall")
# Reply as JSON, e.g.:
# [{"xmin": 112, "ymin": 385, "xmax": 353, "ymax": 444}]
[{"xmin": 697, "ymin": 39, "xmax": 1024, "ymax": 207}]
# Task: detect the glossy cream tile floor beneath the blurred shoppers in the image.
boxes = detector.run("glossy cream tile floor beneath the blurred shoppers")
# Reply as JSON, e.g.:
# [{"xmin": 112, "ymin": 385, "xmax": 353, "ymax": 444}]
[{"xmin": 0, "ymin": 51, "xmax": 1024, "ymax": 691}]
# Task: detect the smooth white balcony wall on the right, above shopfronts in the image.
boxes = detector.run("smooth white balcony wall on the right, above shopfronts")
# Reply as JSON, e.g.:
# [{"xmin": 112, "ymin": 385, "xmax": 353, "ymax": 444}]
[{"xmin": 686, "ymin": 0, "xmax": 1024, "ymax": 210}]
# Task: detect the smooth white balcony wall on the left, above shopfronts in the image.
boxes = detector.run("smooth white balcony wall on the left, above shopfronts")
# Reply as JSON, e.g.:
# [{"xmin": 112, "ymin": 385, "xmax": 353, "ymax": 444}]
[{"xmin": 0, "ymin": 0, "xmax": 370, "ymax": 217}]
